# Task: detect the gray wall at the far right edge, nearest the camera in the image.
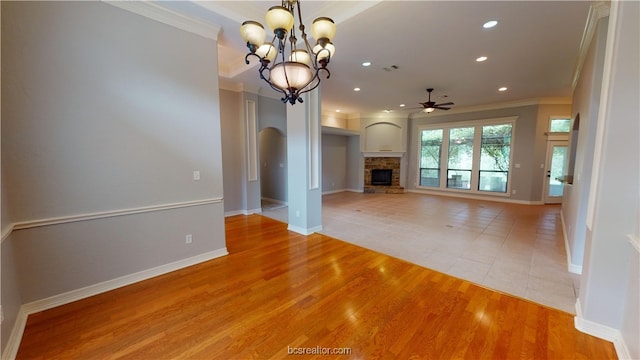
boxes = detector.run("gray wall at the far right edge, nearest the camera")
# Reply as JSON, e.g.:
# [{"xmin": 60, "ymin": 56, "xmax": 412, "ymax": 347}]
[{"xmin": 579, "ymin": 1, "xmax": 640, "ymax": 359}]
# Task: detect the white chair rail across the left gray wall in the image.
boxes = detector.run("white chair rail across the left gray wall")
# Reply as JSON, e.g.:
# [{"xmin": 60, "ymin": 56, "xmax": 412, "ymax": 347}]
[{"xmin": 9, "ymin": 198, "xmax": 222, "ymax": 232}]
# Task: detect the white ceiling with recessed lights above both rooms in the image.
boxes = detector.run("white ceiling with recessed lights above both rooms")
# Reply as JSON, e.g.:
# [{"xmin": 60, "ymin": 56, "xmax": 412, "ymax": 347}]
[{"xmin": 163, "ymin": 0, "xmax": 591, "ymax": 114}]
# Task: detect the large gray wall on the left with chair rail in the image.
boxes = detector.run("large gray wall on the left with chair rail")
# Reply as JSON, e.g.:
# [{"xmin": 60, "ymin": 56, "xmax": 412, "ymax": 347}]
[{"xmin": 1, "ymin": 2, "xmax": 225, "ymax": 347}]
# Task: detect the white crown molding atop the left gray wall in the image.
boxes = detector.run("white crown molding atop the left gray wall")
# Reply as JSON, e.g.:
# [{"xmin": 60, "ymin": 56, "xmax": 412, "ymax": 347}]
[{"xmin": 102, "ymin": 0, "xmax": 221, "ymax": 41}]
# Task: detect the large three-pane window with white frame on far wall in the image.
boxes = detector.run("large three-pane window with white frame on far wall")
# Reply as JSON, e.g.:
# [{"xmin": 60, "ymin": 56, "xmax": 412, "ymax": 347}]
[{"xmin": 418, "ymin": 117, "xmax": 516, "ymax": 195}]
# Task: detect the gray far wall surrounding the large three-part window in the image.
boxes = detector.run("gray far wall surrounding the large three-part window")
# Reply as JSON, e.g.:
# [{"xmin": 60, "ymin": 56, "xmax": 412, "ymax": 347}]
[{"xmin": 406, "ymin": 105, "xmax": 546, "ymax": 202}]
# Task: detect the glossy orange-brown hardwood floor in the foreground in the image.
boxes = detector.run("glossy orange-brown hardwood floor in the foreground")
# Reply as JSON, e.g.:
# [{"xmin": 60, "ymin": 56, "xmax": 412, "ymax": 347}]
[{"xmin": 18, "ymin": 215, "xmax": 616, "ymax": 359}]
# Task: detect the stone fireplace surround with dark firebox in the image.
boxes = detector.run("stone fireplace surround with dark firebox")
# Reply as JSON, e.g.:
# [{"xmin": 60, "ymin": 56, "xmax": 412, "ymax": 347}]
[{"xmin": 364, "ymin": 157, "xmax": 404, "ymax": 194}]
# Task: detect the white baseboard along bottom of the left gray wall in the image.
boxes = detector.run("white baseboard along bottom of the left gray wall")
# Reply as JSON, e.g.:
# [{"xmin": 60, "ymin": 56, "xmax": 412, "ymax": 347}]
[{"xmin": 2, "ymin": 247, "xmax": 229, "ymax": 359}]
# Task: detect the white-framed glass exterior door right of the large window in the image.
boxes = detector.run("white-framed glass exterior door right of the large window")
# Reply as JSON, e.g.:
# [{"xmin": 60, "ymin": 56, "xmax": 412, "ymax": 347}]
[{"xmin": 544, "ymin": 140, "xmax": 569, "ymax": 204}]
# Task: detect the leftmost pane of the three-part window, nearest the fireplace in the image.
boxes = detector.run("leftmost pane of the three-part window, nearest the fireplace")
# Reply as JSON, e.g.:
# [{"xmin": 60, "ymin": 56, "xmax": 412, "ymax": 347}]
[{"xmin": 419, "ymin": 129, "xmax": 442, "ymax": 187}]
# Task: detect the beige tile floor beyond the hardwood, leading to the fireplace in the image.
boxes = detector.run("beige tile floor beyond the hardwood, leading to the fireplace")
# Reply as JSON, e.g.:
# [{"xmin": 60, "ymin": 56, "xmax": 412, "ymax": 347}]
[{"xmin": 262, "ymin": 192, "xmax": 579, "ymax": 314}]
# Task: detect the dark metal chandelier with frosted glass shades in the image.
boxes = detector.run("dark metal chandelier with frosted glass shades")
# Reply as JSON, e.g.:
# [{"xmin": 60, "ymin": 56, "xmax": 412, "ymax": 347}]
[{"xmin": 240, "ymin": 0, "xmax": 336, "ymax": 105}]
